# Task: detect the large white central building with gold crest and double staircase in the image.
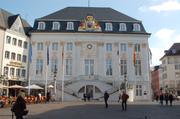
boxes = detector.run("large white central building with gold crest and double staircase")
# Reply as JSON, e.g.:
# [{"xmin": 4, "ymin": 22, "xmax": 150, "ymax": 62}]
[{"xmin": 30, "ymin": 7, "xmax": 151, "ymax": 101}]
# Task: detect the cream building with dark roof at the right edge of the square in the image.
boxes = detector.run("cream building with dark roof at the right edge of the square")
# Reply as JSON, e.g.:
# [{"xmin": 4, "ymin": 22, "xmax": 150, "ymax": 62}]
[{"xmin": 160, "ymin": 43, "xmax": 180, "ymax": 95}]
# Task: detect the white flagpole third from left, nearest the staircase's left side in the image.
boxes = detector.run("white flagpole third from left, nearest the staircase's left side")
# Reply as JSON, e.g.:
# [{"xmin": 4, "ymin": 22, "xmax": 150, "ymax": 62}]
[{"xmin": 61, "ymin": 45, "xmax": 64, "ymax": 102}]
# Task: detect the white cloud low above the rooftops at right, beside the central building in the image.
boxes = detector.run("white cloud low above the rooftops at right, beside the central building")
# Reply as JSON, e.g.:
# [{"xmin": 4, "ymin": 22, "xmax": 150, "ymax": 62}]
[{"xmin": 151, "ymin": 28, "xmax": 180, "ymax": 66}]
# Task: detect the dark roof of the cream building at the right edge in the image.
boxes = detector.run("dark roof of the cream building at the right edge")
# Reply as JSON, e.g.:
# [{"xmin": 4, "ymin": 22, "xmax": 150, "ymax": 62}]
[{"xmin": 161, "ymin": 43, "xmax": 180, "ymax": 59}]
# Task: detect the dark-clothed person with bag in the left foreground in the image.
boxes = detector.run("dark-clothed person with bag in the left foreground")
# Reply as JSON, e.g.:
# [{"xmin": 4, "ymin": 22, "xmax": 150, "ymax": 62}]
[{"xmin": 12, "ymin": 96, "xmax": 28, "ymax": 119}]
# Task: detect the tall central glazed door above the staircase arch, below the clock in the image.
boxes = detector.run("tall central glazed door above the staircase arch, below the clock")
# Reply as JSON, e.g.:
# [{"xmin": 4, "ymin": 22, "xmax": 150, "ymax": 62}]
[{"xmin": 85, "ymin": 59, "xmax": 94, "ymax": 75}]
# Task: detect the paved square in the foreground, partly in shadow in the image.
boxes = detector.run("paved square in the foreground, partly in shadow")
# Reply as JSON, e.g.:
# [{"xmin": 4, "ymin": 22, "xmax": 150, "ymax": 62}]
[{"xmin": 0, "ymin": 102, "xmax": 180, "ymax": 119}]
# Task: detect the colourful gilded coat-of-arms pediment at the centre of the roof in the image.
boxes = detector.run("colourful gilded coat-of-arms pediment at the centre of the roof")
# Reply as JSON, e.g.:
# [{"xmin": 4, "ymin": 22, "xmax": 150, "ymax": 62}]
[{"xmin": 78, "ymin": 16, "xmax": 102, "ymax": 32}]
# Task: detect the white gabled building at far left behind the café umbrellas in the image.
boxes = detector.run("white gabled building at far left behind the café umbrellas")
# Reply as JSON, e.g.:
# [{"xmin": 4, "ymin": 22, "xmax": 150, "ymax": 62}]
[{"xmin": 0, "ymin": 9, "xmax": 30, "ymax": 96}]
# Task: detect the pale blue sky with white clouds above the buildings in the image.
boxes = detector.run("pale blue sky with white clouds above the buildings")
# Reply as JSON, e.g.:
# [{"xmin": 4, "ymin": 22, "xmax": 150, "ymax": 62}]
[{"xmin": 0, "ymin": 0, "xmax": 180, "ymax": 66}]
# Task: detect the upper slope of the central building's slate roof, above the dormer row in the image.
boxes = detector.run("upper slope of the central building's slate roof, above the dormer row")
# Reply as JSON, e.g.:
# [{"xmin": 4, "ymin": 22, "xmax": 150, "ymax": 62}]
[{"xmin": 39, "ymin": 7, "xmax": 139, "ymax": 22}]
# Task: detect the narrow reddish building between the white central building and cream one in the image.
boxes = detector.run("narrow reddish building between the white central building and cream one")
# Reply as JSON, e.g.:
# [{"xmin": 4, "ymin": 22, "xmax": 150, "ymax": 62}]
[{"xmin": 151, "ymin": 66, "xmax": 160, "ymax": 98}]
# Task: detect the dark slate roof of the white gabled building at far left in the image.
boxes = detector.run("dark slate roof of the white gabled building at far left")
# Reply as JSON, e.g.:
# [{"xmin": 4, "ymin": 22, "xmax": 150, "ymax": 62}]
[{"xmin": 0, "ymin": 9, "xmax": 31, "ymax": 34}]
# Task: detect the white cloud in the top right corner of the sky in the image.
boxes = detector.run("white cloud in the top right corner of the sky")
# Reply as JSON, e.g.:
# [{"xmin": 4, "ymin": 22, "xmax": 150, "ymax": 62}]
[{"xmin": 149, "ymin": 0, "xmax": 180, "ymax": 12}]
